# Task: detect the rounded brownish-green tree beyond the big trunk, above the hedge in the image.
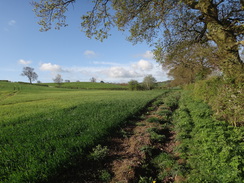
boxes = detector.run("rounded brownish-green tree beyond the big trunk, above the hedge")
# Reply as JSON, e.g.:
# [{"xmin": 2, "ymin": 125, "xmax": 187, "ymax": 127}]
[{"xmin": 161, "ymin": 41, "xmax": 219, "ymax": 86}]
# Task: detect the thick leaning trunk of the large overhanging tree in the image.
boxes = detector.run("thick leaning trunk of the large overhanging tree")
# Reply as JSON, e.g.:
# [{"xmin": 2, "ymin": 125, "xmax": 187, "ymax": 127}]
[{"xmin": 191, "ymin": 0, "xmax": 244, "ymax": 78}]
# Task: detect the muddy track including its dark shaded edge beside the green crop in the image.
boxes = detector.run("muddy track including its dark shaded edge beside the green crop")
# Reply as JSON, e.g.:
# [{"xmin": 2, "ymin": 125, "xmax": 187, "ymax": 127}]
[{"xmin": 48, "ymin": 100, "xmax": 175, "ymax": 183}]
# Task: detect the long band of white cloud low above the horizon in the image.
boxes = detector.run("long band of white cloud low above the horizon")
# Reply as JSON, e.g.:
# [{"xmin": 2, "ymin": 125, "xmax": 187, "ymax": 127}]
[{"xmin": 37, "ymin": 60, "xmax": 166, "ymax": 82}]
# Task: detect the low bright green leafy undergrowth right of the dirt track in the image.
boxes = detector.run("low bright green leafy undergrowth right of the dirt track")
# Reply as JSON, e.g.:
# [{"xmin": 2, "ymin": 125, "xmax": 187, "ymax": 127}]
[{"xmin": 175, "ymin": 92, "xmax": 244, "ymax": 183}]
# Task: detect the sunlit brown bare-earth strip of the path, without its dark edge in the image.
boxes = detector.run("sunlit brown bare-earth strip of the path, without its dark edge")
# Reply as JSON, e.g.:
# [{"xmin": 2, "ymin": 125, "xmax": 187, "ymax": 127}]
[{"xmin": 108, "ymin": 105, "xmax": 175, "ymax": 183}]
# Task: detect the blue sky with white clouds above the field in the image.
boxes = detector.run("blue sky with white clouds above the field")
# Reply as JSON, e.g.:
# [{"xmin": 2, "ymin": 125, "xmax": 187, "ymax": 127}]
[{"xmin": 0, "ymin": 0, "xmax": 168, "ymax": 83}]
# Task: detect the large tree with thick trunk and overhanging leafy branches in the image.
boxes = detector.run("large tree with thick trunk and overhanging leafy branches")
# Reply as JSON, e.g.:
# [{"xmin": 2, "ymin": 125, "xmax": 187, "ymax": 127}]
[{"xmin": 33, "ymin": 0, "xmax": 244, "ymax": 77}]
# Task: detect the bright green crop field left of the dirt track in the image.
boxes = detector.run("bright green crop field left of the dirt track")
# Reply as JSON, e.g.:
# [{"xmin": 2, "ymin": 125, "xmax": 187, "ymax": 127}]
[{"xmin": 0, "ymin": 82, "xmax": 163, "ymax": 183}]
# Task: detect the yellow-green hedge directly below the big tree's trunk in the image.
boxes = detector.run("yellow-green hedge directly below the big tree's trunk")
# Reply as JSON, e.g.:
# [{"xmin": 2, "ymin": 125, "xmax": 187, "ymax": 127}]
[{"xmin": 192, "ymin": 77, "xmax": 244, "ymax": 126}]
